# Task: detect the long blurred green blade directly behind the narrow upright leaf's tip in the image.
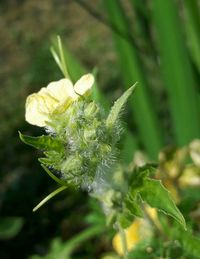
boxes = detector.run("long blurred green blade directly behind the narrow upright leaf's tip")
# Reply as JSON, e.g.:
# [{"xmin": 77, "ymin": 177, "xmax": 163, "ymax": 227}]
[{"xmin": 104, "ymin": 0, "xmax": 163, "ymax": 158}]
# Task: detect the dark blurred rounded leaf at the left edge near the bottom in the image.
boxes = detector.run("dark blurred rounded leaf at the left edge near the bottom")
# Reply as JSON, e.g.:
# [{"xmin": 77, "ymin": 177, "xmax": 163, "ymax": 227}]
[{"xmin": 0, "ymin": 217, "xmax": 24, "ymax": 239}]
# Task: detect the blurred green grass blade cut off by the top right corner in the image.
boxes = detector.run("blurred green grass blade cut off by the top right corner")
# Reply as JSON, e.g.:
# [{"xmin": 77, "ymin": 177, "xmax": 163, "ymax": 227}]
[{"xmin": 184, "ymin": 0, "xmax": 200, "ymax": 73}]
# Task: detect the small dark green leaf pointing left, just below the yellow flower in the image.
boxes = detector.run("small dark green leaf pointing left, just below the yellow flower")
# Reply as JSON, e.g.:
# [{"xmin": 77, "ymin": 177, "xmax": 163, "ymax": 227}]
[{"xmin": 19, "ymin": 132, "xmax": 63, "ymax": 151}]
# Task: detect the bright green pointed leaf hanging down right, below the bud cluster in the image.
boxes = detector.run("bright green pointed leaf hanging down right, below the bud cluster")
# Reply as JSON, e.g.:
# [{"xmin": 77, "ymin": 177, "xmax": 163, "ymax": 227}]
[{"xmin": 140, "ymin": 178, "xmax": 186, "ymax": 232}]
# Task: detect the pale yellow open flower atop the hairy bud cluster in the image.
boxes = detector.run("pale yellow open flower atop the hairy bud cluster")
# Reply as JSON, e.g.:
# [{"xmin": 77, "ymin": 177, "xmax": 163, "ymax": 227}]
[{"xmin": 25, "ymin": 74, "xmax": 94, "ymax": 127}]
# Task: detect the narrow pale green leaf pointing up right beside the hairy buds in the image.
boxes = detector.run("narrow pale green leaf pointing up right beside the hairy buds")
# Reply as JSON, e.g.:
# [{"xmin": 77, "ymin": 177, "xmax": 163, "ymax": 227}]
[{"xmin": 106, "ymin": 83, "xmax": 137, "ymax": 126}]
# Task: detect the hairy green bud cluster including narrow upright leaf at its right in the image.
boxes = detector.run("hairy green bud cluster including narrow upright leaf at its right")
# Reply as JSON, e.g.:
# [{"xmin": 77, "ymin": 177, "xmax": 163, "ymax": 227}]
[{"xmin": 38, "ymin": 82, "xmax": 137, "ymax": 190}]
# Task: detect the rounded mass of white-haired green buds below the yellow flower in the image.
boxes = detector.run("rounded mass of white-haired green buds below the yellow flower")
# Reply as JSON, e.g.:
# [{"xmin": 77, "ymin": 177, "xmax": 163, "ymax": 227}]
[{"xmin": 46, "ymin": 99, "xmax": 119, "ymax": 188}]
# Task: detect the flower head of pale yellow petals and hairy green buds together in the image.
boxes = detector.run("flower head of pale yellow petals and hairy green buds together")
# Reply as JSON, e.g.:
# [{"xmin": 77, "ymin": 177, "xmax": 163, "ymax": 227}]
[{"xmin": 26, "ymin": 74, "xmax": 119, "ymax": 189}]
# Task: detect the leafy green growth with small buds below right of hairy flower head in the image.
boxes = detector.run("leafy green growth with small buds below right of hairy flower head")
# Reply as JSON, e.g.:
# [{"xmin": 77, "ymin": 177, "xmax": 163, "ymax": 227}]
[{"xmin": 95, "ymin": 165, "xmax": 186, "ymax": 233}]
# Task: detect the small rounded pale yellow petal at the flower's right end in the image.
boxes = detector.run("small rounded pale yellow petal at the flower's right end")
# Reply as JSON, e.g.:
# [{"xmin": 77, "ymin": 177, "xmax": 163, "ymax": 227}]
[{"xmin": 74, "ymin": 74, "xmax": 94, "ymax": 95}]
